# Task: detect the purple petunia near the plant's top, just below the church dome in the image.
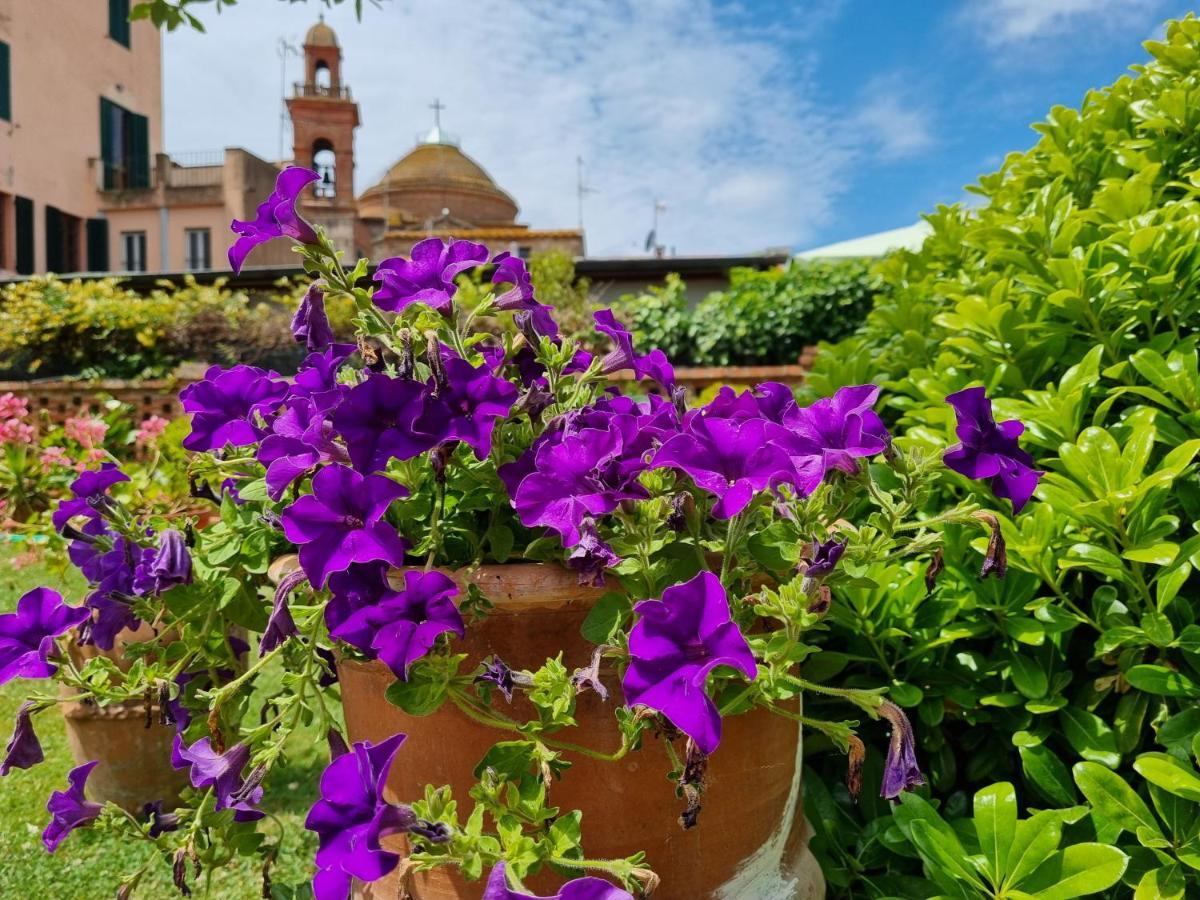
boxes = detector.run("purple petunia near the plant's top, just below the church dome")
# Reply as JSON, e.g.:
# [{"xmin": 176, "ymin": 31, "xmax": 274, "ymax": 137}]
[{"xmin": 372, "ymin": 238, "xmax": 487, "ymax": 313}]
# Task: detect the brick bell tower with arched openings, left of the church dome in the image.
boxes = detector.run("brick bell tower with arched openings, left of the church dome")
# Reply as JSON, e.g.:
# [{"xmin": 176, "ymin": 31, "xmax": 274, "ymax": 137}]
[{"xmin": 288, "ymin": 16, "xmax": 361, "ymax": 264}]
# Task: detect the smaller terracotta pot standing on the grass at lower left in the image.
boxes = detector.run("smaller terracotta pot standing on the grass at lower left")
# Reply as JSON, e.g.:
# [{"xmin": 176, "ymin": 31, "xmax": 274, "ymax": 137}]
[{"xmin": 60, "ymin": 624, "xmax": 187, "ymax": 812}]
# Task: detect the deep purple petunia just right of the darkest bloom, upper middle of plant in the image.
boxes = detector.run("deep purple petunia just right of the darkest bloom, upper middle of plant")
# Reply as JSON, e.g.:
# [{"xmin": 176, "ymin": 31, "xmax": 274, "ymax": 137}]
[{"xmin": 413, "ymin": 356, "xmax": 517, "ymax": 460}]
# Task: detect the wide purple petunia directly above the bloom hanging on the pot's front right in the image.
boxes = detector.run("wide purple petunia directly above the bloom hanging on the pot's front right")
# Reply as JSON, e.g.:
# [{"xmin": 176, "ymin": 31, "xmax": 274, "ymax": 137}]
[{"xmin": 652, "ymin": 416, "xmax": 792, "ymax": 518}]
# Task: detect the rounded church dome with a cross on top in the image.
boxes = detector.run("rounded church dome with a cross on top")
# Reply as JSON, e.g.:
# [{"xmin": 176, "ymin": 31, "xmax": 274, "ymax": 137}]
[{"xmin": 359, "ymin": 138, "xmax": 517, "ymax": 228}]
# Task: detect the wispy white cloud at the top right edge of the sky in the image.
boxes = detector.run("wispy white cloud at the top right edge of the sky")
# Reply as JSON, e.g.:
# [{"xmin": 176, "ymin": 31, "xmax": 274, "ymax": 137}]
[{"xmin": 964, "ymin": 0, "xmax": 1162, "ymax": 47}]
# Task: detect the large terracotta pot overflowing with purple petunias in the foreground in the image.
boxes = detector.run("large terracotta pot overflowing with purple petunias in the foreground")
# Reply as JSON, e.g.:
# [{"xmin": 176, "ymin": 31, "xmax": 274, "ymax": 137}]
[{"xmin": 0, "ymin": 168, "xmax": 1039, "ymax": 900}]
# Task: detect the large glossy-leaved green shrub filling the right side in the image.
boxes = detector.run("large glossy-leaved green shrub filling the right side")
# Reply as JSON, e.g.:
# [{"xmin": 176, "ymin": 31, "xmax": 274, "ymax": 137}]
[{"xmin": 809, "ymin": 17, "xmax": 1200, "ymax": 896}]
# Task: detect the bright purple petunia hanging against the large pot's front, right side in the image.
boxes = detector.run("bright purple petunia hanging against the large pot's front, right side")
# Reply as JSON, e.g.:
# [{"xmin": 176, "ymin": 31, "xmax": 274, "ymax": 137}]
[{"xmin": 622, "ymin": 571, "xmax": 758, "ymax": 754}]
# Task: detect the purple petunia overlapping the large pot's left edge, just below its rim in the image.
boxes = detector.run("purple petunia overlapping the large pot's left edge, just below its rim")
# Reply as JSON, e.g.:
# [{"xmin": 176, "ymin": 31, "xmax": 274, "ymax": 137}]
[{"xmin": 330, "ymin": 569, "xmax": 466, "ymax": 680}]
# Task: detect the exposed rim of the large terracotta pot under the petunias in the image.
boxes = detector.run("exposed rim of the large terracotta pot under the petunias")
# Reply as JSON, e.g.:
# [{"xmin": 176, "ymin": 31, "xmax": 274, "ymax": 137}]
[{"xmin": 268, "ymin": 553, "xmax": 604, "ymax": 616}]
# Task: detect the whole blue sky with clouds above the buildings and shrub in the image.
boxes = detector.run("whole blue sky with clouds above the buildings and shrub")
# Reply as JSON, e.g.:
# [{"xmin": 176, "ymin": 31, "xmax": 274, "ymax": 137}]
[{"xmin": 164, "ymin": 0, "xmax": 1187, "ymax": 254}]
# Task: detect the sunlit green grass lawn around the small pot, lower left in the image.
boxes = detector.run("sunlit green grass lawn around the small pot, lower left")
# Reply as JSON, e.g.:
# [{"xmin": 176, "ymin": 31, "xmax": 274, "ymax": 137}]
[{"xmin": 0, "ymin": 545, "xmax": 328, "ymax": 900}]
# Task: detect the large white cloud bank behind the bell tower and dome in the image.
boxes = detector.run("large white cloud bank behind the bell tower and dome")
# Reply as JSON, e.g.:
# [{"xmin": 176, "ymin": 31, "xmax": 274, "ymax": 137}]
[{"xmin": 164, "ymin": 0, "xmax": 864, "ymax": 254}]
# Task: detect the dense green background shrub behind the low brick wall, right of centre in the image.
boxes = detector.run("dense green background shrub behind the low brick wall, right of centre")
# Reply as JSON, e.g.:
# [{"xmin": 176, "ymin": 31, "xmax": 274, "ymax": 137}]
[{"xmin": 618, "ymin": 259, "xmax": 877, "ymax": 366}]
